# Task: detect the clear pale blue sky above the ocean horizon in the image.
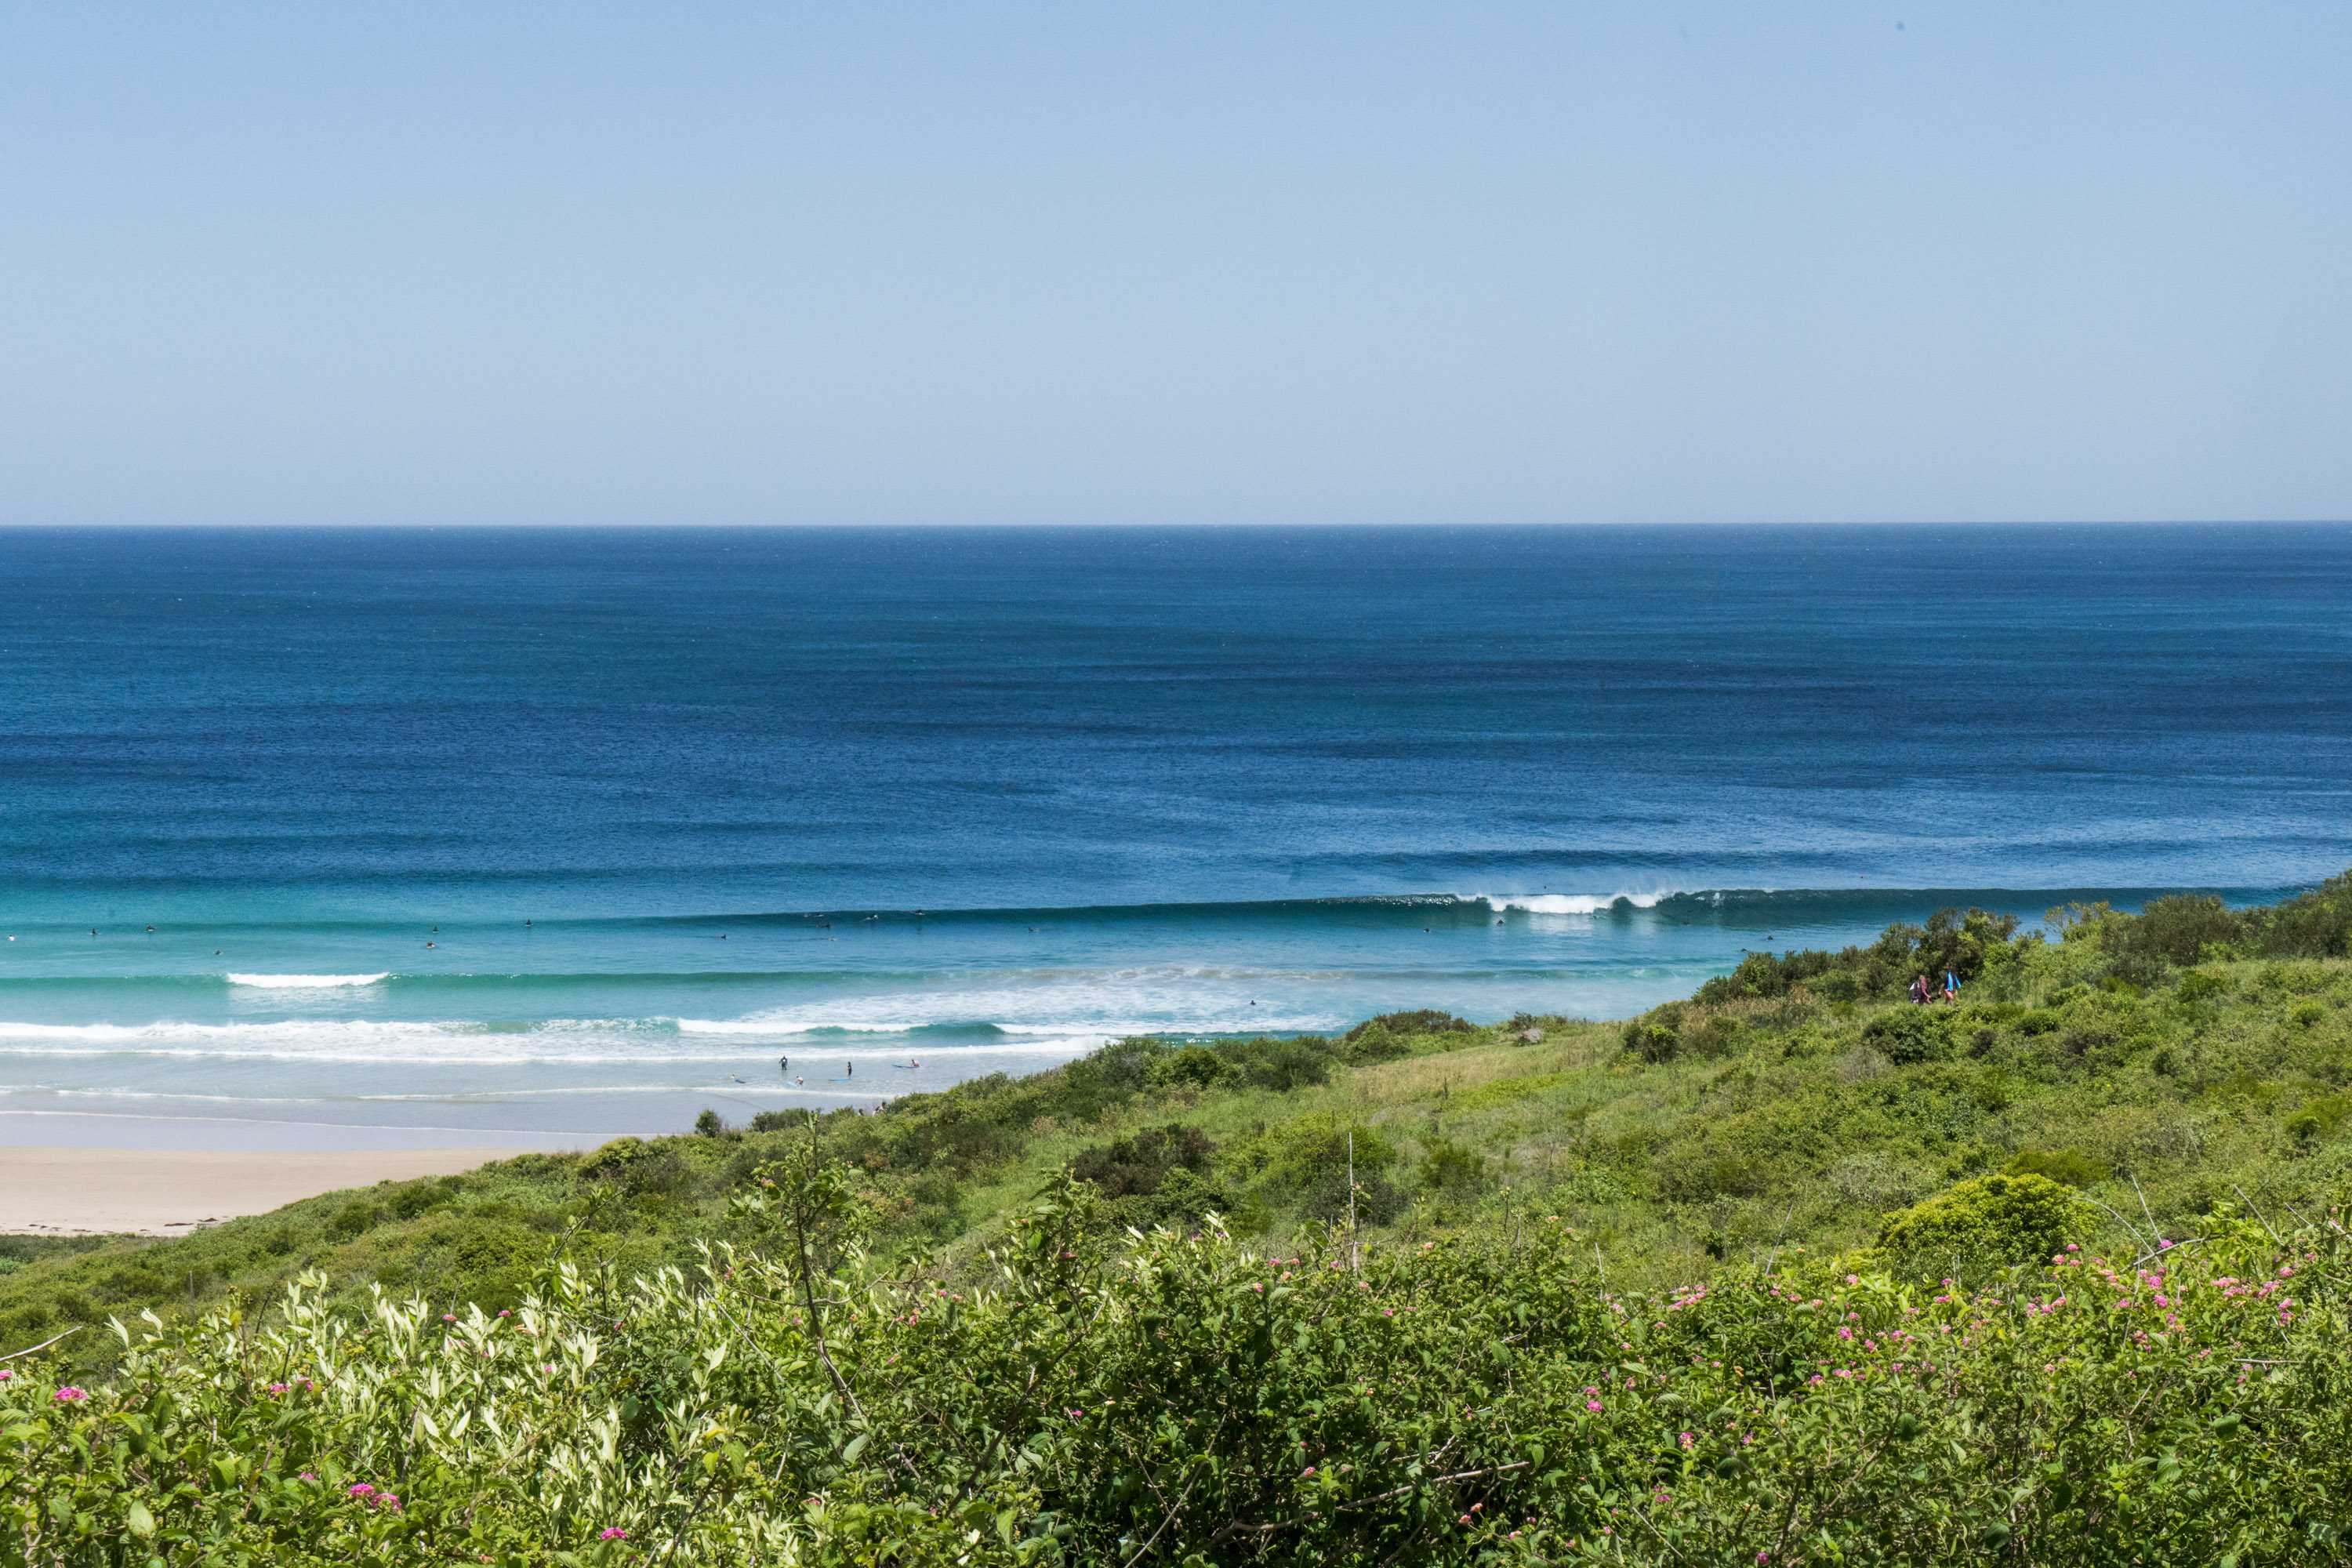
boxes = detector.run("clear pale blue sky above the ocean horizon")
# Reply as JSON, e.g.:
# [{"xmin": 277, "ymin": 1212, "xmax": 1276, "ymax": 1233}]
[{"xmin": 0, "ymin": 0, "xmax": 2352, "ymax": 522}]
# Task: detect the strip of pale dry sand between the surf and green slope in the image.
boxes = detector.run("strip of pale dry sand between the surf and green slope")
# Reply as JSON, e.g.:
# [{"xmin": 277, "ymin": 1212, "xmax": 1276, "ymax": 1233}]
[{"xmin": 0, "ymin": 1145, "xmax": 534, "ymax": 1236}]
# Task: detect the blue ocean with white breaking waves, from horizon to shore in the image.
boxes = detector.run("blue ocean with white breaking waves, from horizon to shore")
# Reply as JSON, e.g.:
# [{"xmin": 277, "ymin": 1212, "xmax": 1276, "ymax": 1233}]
[{"xmin": 0, "ymin": 527, "xmax": 2352, "ymax": 1142}]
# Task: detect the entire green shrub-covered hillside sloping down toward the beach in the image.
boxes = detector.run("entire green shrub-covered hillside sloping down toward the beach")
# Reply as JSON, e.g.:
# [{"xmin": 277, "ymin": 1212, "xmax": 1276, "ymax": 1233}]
[{"xmin": 0, "ymin": 874, "xmax": 2352, "ymax": 1568}]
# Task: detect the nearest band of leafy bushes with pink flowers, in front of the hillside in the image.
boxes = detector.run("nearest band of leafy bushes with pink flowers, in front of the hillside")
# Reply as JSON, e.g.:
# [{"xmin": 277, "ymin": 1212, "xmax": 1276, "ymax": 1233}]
[{"xmin": 0, "ymin": 1185, "xmax": 2352, "ymax": 1568}]
